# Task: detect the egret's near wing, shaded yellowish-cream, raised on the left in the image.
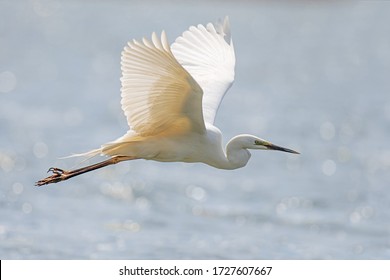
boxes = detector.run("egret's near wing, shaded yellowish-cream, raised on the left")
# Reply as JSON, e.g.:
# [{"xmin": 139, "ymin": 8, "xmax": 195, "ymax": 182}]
[{"xmin": 121, "ymin": 31, "xmax": 205, "ymax": 136}]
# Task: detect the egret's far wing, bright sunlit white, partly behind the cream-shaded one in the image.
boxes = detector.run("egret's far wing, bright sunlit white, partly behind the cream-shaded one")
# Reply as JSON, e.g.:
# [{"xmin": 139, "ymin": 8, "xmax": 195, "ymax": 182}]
[{"xmin": 171, "ymin": 17, "xmax": 235, "ymax": 124}]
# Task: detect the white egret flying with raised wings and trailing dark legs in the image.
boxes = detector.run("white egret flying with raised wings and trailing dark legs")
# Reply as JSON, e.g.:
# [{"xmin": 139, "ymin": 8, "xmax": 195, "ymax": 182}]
[{"xmin": 36, "ymin": 17, "xmax": 298, "ymax": 186}]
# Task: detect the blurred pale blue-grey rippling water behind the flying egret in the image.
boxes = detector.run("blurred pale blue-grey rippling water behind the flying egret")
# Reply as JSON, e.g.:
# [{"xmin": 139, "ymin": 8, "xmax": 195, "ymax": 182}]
[{"xmin": 0, "ymin": 0, "xmax": 390, "ymax": 259}]
